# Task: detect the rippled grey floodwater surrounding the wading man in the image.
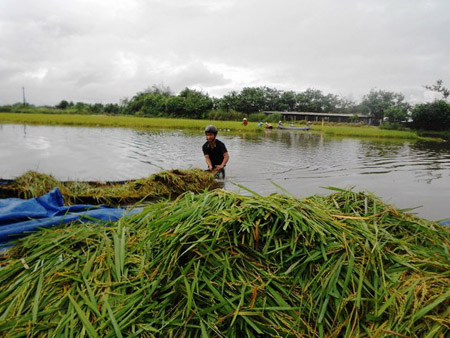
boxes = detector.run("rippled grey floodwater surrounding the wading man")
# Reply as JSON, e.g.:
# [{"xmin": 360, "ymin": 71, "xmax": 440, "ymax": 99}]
[{"xmin": 0, "ymin": 124, "xmax": 450, "ymax": 220}]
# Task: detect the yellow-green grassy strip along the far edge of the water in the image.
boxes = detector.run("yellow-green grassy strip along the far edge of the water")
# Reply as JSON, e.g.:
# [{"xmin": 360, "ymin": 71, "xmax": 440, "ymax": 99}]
[{"xmin": 0, "ymin": 113, "xmax": 434, "ymax": 140}]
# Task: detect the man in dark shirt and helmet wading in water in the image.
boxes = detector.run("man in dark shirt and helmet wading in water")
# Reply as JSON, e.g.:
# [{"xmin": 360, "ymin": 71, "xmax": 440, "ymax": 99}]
[{"xmin": 202, "ymin": 126, "xmax": 230, "ymax": 178}]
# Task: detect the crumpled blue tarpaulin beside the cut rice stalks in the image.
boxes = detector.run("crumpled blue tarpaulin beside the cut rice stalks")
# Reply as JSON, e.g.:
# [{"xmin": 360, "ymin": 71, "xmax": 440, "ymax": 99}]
[{"xmin": 0, "ymin": 188, "xmax": 139, "ymax": 248}]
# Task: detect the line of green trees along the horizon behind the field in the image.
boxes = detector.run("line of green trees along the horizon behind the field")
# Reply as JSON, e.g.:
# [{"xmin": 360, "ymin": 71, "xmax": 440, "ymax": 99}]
[{"xmin": 0, "ymin": 80, "xmax": 450, "ymax": 130}]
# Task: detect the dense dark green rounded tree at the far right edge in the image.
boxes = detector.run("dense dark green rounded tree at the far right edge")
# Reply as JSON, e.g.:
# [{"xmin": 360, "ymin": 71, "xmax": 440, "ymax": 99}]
[{"xmin": 411, "ymin": 100, "xmax": 450, "ymax": 131}]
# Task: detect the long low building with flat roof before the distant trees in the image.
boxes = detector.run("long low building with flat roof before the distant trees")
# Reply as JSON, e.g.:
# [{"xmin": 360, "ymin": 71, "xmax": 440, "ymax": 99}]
[{"xmin": 264, "ymin": 111, "xmax": 375, "ymax": 124}]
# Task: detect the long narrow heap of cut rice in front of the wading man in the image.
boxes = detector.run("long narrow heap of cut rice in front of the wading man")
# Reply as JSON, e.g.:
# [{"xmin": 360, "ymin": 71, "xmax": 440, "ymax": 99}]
[{"xmin": 0, "ymin": 169, "xmax": 219, "ymax": 205}]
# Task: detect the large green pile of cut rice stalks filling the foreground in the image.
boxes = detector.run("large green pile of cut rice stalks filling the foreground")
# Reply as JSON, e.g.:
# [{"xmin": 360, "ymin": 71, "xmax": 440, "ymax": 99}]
[{"xmin": 0, "ymin": 190, "xmax": 450, "ymax": 338}]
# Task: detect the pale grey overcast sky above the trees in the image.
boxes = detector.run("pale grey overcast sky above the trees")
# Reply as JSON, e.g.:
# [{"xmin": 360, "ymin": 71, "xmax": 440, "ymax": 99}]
[{"xmin": 0, "ymin": 0, "xmax": 450, "ymax": 105}]
